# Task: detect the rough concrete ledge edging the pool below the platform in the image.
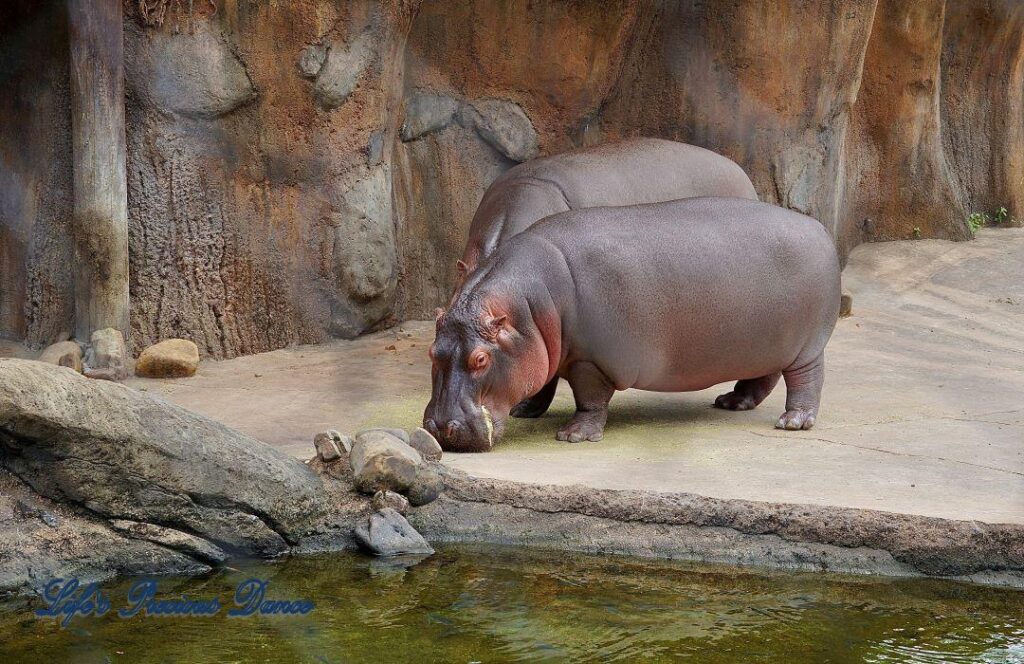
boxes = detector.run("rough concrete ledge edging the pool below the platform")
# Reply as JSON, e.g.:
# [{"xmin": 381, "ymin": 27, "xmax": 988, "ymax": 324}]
[{"xmin": 410, "ymin": 471, "xmax": 1024, "ymax": 588}]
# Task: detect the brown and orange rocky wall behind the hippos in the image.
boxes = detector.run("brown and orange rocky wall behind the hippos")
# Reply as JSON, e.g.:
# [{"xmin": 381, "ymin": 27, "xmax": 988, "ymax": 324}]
[{"xmin": 0, "ymin": 0, "xmax": 1024, "ymax": 357}]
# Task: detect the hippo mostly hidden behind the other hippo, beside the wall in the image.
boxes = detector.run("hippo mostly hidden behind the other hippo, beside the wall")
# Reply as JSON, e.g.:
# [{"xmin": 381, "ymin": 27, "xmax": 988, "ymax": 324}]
[{"xmin": 457, "ymin": 138, "xmax": 758, "ymax": 417}]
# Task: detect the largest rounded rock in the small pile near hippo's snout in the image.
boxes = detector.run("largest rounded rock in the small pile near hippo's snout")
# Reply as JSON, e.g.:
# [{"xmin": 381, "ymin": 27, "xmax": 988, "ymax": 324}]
[{"xmin": 349, "ymin": 431, "xmax": 423, "ymax": 494}]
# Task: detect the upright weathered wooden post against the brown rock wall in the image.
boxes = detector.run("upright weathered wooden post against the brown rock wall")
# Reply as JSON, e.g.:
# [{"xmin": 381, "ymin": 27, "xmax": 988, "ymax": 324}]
[{"xmin": 68, "ymin": 0, "xmax": 128, "ymax": 341}]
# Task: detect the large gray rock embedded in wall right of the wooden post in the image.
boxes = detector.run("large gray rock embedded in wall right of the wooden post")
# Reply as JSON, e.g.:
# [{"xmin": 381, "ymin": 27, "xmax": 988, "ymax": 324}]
[{"xmin": 125, "ymin": 20, "xmax": 256, "ymax": 118}]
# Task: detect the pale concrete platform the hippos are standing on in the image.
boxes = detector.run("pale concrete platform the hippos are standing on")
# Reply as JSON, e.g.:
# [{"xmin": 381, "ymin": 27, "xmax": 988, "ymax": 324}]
[{"xmin": 90, "ymin": 230, "xmax": 1024, "ymax": 524}]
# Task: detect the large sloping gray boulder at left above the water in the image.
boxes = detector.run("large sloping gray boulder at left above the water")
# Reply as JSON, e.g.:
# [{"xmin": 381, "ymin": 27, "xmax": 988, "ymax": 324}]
[{"xmin": 0, "ymin": 360, "xmax": 328, "ymax": 555}]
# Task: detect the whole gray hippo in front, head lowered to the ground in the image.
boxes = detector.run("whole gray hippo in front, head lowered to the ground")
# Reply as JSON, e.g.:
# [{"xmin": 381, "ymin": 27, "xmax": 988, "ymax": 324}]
[{"xmin": 424, "ymin": 198, "xmax": 840, "ymax": 451}]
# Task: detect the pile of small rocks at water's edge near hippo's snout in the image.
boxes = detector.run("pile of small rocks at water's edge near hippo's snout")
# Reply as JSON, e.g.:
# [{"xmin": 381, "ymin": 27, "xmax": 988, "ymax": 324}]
[{"xmin": 313, "ymin": 428, "xmax": 444, "ymax": 555}]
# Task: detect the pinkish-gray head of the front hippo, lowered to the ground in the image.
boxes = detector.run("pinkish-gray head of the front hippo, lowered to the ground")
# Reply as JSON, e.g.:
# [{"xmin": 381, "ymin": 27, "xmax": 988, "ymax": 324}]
[{"xmin": 423, "ymin": 294, "xmax": 549, "ymax": 452}]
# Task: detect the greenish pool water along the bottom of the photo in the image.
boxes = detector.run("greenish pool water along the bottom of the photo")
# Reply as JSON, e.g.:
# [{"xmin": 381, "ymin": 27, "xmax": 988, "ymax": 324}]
[{"xmin": 0, "ymin": 547, "xmax": 1024, "ymax": 663}]
